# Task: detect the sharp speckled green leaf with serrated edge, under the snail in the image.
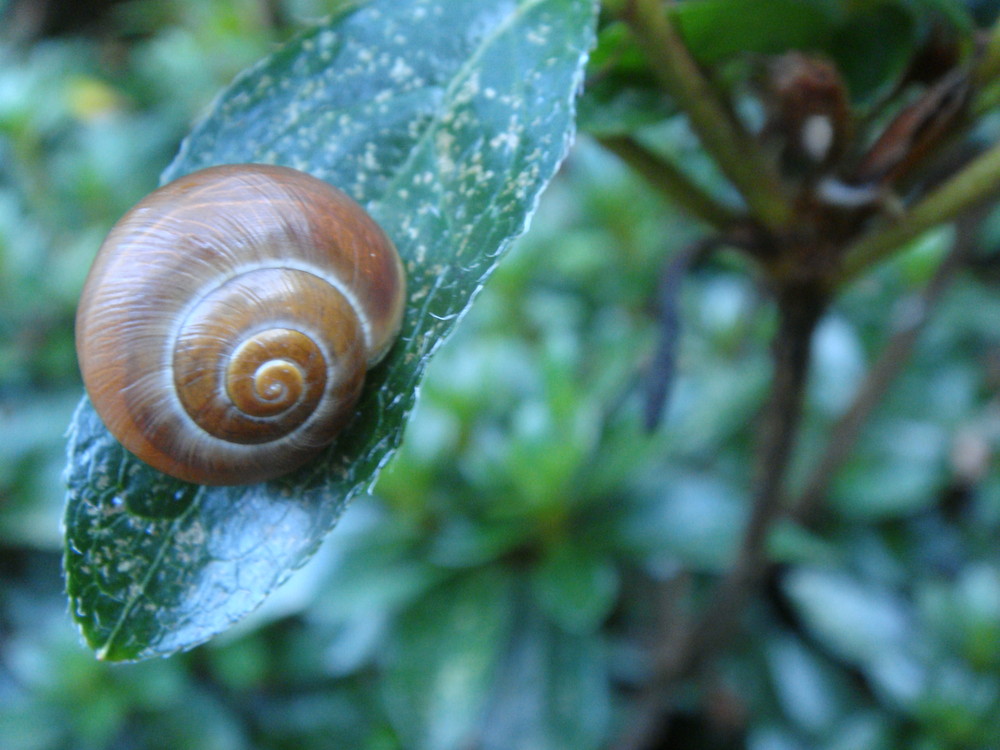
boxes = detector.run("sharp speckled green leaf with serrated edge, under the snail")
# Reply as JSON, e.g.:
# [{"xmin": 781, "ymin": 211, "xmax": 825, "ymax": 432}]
[{"xmin": 65, "ymin": 0, "xmax": 596, "ymax": 660}]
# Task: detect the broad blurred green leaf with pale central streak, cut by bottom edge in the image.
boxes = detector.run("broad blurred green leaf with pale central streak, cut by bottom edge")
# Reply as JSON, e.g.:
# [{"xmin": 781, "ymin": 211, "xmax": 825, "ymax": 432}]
[{"xmin": 384, "ymin": 568, "xmax": 514, "ymax": 750}]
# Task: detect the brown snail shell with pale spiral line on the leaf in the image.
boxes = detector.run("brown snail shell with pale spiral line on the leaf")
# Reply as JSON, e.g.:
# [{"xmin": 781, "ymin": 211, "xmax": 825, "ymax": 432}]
[{"xmin": 76, "ymin": 164, "xmax": 405, "ymax": 485}]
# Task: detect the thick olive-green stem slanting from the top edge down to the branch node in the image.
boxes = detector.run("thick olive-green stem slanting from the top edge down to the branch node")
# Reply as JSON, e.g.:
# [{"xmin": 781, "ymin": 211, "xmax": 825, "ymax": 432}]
[{"xmin": 607, "ymin": 0, "xmax": 793, "ymax": 230}]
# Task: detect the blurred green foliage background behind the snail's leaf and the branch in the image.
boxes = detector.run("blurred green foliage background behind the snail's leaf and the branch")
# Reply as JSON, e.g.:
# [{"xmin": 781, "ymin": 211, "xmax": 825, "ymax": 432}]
[{"xmin": 0, "ymin": 0, "xmax": 1000, "ymax": 750}]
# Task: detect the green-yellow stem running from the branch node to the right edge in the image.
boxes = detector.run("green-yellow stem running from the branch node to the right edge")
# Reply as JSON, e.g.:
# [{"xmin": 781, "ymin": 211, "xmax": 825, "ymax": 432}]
[{"xmin": 838, "ymin": 144, "xmax": 1000, "ymax": 283}]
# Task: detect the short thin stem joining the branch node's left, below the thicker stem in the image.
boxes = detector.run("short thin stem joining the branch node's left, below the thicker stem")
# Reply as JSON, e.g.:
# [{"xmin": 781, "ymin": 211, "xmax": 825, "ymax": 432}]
[{"xmin": 599, "ymin": 136, "xmax": 739, "ymax": 230}]
